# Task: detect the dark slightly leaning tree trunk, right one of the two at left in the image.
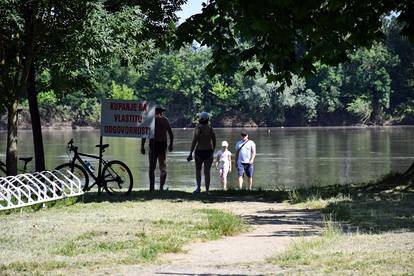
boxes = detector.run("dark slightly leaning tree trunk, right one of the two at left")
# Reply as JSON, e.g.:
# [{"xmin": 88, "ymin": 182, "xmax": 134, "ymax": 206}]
[{"xmin": 27, "ymin": 63, "xmax": 45, "ymax": 172}]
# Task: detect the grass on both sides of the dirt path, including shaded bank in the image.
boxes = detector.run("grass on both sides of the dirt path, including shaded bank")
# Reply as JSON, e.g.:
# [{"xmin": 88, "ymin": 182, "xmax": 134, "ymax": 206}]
[{"xmin": 0, "ymin": 175, "xmax": 414, "ymax": 274}]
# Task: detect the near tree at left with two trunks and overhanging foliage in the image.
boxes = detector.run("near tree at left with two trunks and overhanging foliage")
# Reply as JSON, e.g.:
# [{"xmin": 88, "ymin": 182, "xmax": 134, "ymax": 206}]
[{"xmin": 0, "ymin": 0, "xmax": 184, "ymax": 174}]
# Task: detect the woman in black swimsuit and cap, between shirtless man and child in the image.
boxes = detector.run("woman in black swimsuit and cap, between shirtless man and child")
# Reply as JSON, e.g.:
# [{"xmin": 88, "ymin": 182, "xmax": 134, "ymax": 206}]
[{"xmin": 187, "ymin": 112, "xmax": 216, "ymax": 193}]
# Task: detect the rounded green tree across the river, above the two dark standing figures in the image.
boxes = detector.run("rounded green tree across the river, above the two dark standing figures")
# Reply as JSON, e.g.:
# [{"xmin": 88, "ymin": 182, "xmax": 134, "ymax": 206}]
[{"xmin": 137, "ymin": 47, "xmax": 211, "ymax": 123}]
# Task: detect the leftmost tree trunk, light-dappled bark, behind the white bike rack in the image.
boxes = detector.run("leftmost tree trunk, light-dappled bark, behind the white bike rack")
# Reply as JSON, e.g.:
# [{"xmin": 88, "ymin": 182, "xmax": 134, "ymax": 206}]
[{"xmin": 6, "ymin": 99, "xmax": 19, "ymax": 175}]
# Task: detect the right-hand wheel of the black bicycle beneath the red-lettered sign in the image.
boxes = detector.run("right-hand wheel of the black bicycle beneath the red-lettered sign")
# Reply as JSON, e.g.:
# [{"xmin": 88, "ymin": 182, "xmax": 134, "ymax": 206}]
[{"xmin": 102, "ymin": 160, "xmax": 134, "ymax": 195}]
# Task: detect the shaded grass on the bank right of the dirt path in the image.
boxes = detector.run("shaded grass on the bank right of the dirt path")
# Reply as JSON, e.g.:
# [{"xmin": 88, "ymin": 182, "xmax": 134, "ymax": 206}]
[{"xmin": 289, "ymin": 174, "xmax": 414, "ymax": 233}]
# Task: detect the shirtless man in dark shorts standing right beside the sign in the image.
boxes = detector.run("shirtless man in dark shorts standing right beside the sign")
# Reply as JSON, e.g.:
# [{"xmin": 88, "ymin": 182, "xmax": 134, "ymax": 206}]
[{"xmin": 141, "ymin": 107, "xmax": 174, "ymax": 191}]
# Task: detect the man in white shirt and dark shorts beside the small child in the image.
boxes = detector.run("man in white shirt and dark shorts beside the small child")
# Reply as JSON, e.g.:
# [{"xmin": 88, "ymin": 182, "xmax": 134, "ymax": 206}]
[{"xmin": 236, "ymin": 131, "xmax": 256, "ymax": 190}]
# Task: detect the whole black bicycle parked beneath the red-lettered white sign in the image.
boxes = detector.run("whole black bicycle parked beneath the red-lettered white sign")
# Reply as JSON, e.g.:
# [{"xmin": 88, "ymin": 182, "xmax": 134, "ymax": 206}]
[{"xmin": 55, "ymin": 139, "xmax": 133, "ymax": 195}]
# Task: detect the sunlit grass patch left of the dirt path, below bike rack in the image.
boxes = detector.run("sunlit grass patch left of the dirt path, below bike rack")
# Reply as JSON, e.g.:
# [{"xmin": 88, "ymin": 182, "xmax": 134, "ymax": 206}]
[{"xmin": 0, "ymin": 196, "xmax": 248, "ymax": 275}]
